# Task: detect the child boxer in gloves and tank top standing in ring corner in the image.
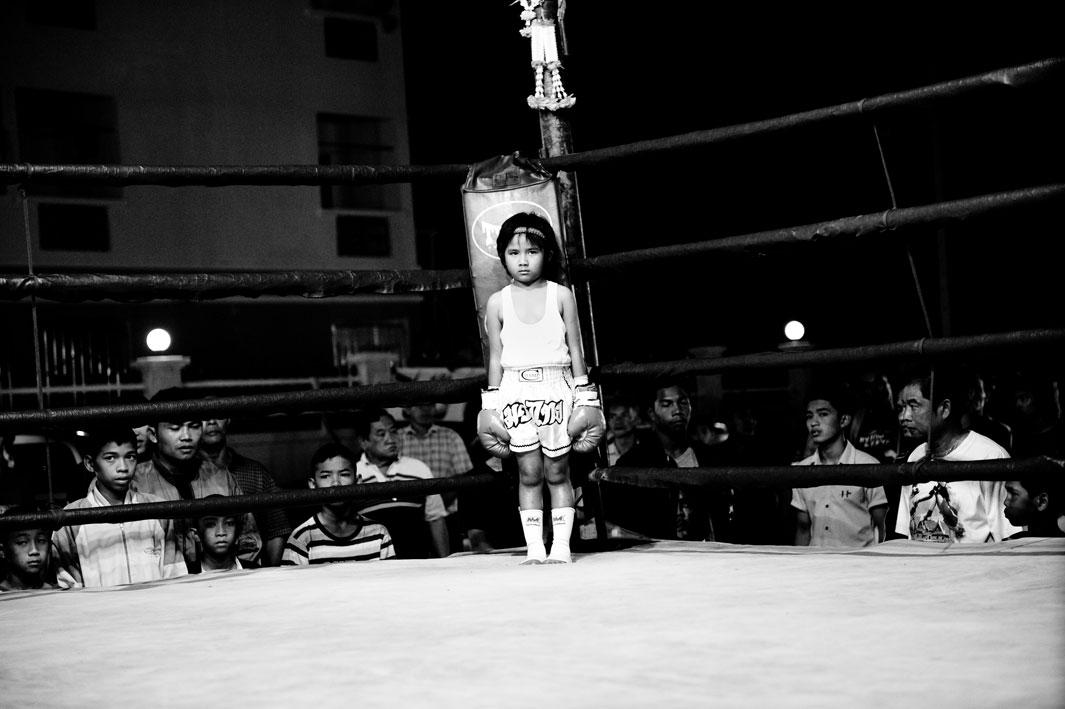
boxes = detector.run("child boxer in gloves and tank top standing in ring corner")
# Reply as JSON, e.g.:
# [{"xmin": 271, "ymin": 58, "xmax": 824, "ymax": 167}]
[{"xmin": 477, "ymin": 213, "xmax": 606, "ymax": 564}]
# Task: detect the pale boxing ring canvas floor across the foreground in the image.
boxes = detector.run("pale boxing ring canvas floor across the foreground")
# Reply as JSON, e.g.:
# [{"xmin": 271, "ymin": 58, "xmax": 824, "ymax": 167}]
[{"xmin": 0, "ymin": 540, "xmax": 1065, "ymax": 707}]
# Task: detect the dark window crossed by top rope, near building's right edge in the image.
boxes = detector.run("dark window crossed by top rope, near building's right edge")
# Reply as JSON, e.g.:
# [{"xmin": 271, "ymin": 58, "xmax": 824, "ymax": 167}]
[{"xmin": 318, "ymin": 113, "xmax": 399, "ymax": 210}]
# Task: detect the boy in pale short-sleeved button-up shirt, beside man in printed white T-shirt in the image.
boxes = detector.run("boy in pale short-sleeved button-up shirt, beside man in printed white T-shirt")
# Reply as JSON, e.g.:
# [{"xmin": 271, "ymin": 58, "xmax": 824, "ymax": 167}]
[{"xmin": 791, "ymin": 391, "xmax": 887, "ymax": 546}]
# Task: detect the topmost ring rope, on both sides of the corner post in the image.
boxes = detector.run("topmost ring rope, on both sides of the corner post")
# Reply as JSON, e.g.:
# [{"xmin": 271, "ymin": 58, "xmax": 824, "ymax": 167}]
[{"xmin": 0, "ymin": 57, "xmax": 1065, "ymax": 186}]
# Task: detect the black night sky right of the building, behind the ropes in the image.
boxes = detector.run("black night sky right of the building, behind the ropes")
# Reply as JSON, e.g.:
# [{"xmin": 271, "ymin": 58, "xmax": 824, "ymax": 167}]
[{"xmin": 400, "ymin": 1, "xmax": 1065, "ymax": 362}]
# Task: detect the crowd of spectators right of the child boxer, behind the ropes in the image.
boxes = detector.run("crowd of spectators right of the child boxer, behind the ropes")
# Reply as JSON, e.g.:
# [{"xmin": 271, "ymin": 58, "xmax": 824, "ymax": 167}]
[{"xmin": 602, "ymin": 366, "xmax": 1065, "ymax": 546}]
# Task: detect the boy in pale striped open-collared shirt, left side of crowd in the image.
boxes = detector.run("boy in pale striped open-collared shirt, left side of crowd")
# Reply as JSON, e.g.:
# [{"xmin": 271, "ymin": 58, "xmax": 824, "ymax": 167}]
[{"xmin": 52, "ymin": 427, "xmax": 187, "ymax": 587}]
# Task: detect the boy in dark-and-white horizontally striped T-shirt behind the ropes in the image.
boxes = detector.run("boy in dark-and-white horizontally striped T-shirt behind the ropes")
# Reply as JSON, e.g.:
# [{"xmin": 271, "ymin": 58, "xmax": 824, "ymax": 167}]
[{"xmin": 281, "ymin": 443, "xmax": 395, "ymax": 566}]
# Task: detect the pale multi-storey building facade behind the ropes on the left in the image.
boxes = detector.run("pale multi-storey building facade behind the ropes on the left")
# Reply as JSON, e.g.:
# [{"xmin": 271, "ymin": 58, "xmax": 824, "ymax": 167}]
[{"xmin": 0, "ymin": 0, "xmax": 428, "ymax": 408}]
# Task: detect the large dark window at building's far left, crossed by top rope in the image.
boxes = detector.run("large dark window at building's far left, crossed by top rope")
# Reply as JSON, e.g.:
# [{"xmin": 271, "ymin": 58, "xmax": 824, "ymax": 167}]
[{"xmin": 15, "ymin": 88, "xmax": 122, "ymax": 198}]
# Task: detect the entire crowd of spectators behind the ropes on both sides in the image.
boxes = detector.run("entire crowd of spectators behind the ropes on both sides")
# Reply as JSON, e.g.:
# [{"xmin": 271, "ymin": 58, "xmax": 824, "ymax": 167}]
[{"xmin": 0, "ymin": 367, "xmax": 1065, "ymax": 591}]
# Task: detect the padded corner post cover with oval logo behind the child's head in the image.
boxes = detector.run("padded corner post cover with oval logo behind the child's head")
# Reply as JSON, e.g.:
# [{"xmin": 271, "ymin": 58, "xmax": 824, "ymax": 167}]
[{"xmin": 462, "ymin": 154, "xmax": 569, "ymax": 367}]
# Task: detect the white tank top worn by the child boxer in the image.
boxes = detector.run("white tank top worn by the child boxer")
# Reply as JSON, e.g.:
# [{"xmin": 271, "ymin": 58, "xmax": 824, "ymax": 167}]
[{"xmin": 499, "ymin": 281, "xmax": 570, "ymax": 369}]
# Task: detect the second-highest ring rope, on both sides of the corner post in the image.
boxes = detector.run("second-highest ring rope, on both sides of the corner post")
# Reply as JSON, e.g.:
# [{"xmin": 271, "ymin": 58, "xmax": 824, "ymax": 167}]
[{"xmin": 0, "ymin": 184, "xmax": 1065, "ymax": 302}]
